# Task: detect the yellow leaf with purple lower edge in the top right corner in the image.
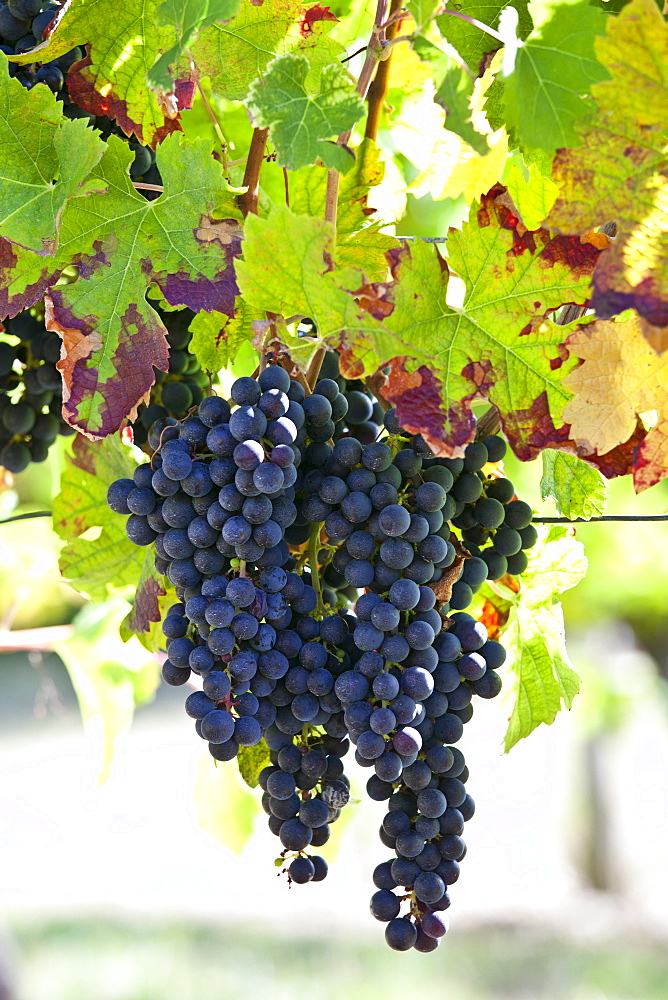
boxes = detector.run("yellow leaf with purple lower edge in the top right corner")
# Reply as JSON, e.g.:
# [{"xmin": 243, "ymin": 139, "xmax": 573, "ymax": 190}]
[{"xmin": 548, "ymin": 0, "xmax": 668, "ymax": 336}]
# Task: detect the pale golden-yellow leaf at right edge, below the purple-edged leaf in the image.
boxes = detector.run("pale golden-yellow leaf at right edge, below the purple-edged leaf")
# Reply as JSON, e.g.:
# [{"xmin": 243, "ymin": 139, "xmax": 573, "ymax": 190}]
[{"xmin": 564, "ymin": 315, "xmax": 668, "ymax": 493}]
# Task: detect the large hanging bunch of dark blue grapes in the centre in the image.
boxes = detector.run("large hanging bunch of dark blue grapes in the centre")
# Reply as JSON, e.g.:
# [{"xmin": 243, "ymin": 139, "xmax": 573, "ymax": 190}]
[{"xmin": 108, "ymin": 355, "xmax": 535, "ymax": 952}]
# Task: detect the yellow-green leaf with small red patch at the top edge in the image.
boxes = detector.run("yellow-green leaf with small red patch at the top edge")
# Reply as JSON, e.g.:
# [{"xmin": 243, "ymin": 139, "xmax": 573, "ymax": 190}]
[{"xmin": 191, "ymin": 0, "xmax": 343, "ymax": 101}]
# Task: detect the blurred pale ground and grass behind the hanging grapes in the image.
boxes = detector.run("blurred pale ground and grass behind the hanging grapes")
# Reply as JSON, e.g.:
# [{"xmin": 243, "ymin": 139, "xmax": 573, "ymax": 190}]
[{"xmin": 0, "ymin": 640, "xmax": 668, "ymax": 1000}]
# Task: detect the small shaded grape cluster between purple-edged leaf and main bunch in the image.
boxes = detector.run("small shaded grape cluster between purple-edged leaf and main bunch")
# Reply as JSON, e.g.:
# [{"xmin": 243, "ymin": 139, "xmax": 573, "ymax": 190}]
[{"xmin": 132, "ymin": 306, "xmax": 208, "ymax": 447}]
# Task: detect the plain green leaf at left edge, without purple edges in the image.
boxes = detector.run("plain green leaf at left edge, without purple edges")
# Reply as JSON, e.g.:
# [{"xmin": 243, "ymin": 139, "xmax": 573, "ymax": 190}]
[{"xmin": 0, "ymin": 55, "xmax": 105, "ymax": 254}]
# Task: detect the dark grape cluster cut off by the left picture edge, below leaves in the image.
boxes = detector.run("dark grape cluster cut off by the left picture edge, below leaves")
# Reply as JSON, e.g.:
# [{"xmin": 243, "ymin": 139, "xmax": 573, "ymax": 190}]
[{"xmin": 0, "ymin": 312, "xmax": 74, "ymax": 473}]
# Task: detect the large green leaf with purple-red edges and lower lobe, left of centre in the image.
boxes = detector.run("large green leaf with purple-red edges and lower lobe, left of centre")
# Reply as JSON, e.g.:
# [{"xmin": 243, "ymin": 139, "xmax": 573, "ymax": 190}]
[{"xmin": 47, "ymin": 135, "xmax": 242, "ymax": 438}]
